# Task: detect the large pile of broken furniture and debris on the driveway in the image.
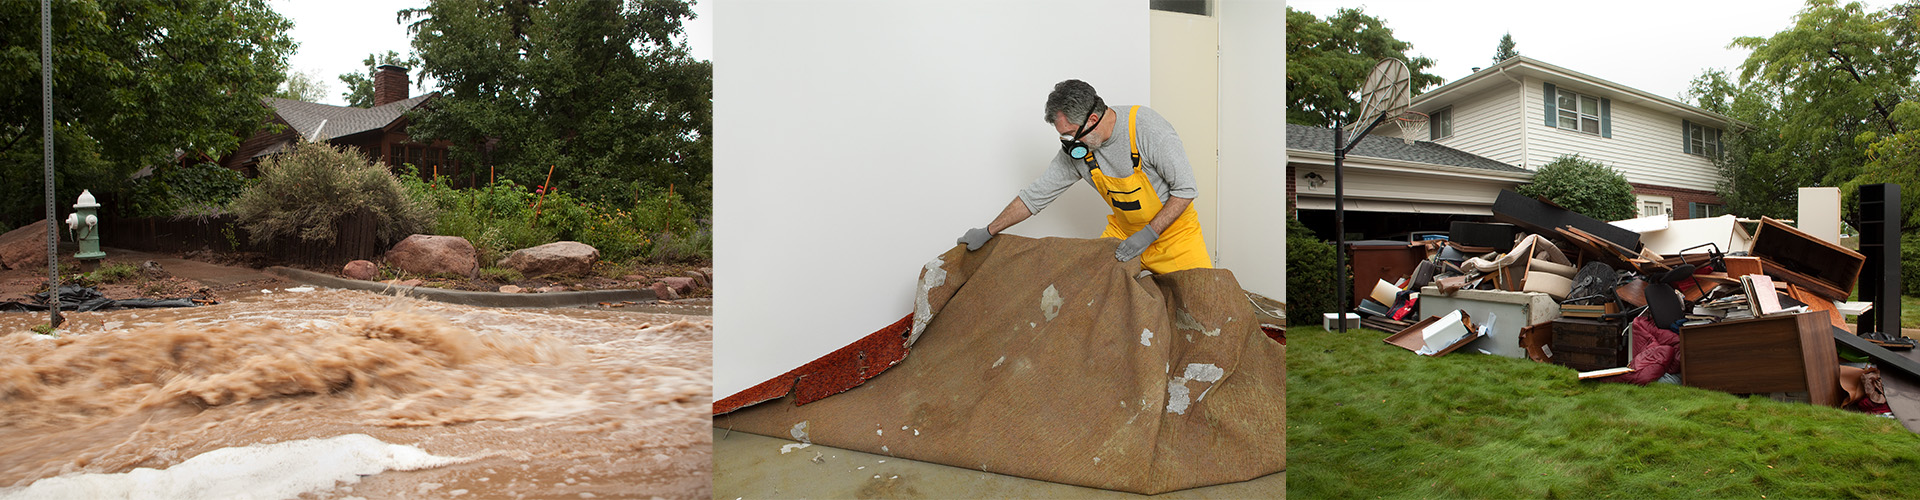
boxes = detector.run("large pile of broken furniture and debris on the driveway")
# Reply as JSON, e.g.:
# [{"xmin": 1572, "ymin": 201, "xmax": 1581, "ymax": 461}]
[{"xmin": 1351, "ymin": 190, "xmax": 1920, "ymax": 415}]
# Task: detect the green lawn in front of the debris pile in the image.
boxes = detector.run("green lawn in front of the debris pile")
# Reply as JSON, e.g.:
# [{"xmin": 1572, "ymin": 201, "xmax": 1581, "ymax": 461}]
[{"xmin": 1286, "ymin": 327, "xmax": 1920, "ymax": 498}]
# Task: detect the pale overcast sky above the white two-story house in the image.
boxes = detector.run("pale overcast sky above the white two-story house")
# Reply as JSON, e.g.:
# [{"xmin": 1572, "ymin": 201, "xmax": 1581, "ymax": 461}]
[{"xmin": 1286, "ymin": 0, "xmax": 1850, "ymax": 100}]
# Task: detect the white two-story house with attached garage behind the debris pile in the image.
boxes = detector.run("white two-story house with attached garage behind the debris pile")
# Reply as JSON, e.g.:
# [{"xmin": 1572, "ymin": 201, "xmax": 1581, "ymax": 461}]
[{"xmin": 1286, "ymin": 56, "xmax": 1736, "ymax": 238}]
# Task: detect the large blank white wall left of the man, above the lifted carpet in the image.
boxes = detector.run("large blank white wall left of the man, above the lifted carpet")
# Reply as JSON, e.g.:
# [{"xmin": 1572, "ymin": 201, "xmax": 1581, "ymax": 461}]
[{"xmin": 714, "ymin": 0, "xmax": 1144, "ymax": 398}]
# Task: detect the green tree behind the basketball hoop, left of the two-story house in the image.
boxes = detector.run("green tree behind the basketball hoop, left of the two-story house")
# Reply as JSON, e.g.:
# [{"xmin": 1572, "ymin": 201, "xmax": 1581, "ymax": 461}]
[{"xmin": 1286, "ymin": 8, "xmax": 1440, "ymax": 127}]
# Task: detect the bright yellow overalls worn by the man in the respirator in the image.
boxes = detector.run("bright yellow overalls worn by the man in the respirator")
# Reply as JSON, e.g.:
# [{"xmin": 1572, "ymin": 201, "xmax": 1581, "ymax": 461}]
[{"xmin": 1083, "ymin": 106, "xmax": 1213, "ymax": 275}]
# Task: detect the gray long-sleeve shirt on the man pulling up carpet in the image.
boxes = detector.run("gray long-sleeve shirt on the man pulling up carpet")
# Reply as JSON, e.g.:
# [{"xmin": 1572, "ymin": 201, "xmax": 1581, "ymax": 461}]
[{"xmin": 1020, "ymin": 106, "xmax": 1200, "ymax": 213}]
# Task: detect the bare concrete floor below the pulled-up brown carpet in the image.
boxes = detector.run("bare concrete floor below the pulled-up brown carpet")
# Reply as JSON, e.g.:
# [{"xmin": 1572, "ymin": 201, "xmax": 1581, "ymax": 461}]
[{"xmin": 712, "ymin": 429, "xmax": 1286, "ymax": 500}]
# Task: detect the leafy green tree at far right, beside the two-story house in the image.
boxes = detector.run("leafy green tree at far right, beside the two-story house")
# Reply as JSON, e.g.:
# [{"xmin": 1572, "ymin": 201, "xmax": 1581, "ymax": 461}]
[{"xmin": 1693, "ymin": 0, "xmax": 1920, "ymax": 229}]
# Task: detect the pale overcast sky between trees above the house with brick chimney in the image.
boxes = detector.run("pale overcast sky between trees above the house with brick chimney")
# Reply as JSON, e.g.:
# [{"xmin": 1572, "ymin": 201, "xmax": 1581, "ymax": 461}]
[{"xmin": 271, "ymin": 0, "xmax": 712, "ymax": 106}]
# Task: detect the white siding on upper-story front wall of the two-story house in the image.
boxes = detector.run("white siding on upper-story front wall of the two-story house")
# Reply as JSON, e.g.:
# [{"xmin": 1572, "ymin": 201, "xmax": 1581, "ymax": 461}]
[{"xmin": 1524, "ymin": 77, "xmax": 1720, "ymax": 190}]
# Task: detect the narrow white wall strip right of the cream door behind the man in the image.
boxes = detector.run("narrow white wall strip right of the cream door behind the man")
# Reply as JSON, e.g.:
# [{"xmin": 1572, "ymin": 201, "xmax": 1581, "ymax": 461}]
[{"xmin": 1210, "ymin": 0, "xmax": 1286, "ymax": 302}]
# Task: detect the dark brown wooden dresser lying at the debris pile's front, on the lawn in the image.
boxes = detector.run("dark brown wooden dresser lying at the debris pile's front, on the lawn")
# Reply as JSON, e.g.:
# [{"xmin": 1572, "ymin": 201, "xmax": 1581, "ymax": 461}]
[{"xmin": 1680, "ymin": 312, "xmax": 1841, "ymax": 406}]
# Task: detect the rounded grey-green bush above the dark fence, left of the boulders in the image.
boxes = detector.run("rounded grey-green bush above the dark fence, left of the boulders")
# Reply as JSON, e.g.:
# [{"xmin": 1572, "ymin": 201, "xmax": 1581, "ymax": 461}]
[{"xmin": 232, "ymin": 142, "xmax": 434, "ymax": 244}]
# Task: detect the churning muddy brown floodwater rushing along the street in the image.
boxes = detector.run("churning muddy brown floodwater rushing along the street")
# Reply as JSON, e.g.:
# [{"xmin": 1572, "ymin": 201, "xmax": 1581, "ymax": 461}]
[{"xmin": 0, "ymin": 290, "xmax": 712, "ymax": 498}]
